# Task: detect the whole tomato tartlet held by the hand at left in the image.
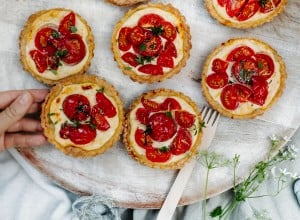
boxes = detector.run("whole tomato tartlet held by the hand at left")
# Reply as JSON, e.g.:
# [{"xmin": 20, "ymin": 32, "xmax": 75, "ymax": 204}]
[{"xmin": 41, "ymin": 74, "xmax": 124, "ymax": 157}]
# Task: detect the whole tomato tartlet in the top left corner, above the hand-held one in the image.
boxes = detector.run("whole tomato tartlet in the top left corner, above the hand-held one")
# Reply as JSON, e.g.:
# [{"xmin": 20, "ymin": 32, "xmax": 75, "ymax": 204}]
[{"xmin": 19, "ymin": 8, "xmax": 94, "ymax": 85}]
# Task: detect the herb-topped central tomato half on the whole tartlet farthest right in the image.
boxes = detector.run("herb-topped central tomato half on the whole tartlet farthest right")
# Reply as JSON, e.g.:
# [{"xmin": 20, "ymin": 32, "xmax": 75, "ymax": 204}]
[{"xmin": 231, "ymin": 58, "xmax": 258, "ymax": 84}]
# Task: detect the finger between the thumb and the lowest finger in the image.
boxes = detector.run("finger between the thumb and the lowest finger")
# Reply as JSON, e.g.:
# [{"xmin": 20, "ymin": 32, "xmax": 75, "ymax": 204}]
[{"xmin": 6, "ymin": 118, "xmax": 43, "ymax": 132}]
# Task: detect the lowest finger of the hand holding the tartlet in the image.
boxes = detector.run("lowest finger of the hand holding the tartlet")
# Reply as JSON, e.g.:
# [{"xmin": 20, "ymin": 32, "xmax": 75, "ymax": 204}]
[{"xmin": 4, "ymin": 133, "xmax": 47, "ymax": 148}]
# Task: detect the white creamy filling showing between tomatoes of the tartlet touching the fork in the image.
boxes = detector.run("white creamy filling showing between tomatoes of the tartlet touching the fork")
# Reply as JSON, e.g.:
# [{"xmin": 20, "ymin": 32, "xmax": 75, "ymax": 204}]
[{"xmin": 129, "ymin": 96, "xmax": 199, "ymax": 164}]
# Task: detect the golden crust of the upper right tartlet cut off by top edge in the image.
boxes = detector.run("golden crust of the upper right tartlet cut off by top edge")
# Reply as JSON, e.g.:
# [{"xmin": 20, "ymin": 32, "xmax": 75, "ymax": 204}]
[{"xmin": 205, "ymin": 0, "xmax": 287, "ymax": 29}]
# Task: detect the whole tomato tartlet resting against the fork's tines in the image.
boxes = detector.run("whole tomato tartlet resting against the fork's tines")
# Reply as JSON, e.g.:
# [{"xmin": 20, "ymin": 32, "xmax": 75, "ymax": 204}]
[{"xmin": 124, "ymin": 89, "xmax": 203, "ymax": 169}]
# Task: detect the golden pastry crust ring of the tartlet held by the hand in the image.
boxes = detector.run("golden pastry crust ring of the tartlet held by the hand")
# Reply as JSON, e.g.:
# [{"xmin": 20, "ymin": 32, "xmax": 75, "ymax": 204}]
[{"xmin": 41, "ymin": 74, "xmax": 124, "ymax": 157}]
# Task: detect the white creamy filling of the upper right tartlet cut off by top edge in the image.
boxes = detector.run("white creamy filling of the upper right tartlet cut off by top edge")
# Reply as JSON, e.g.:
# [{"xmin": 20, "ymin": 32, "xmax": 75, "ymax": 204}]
[{"xmin": 212, "ymin": 0, "xmax": 273, "ymax": 23}]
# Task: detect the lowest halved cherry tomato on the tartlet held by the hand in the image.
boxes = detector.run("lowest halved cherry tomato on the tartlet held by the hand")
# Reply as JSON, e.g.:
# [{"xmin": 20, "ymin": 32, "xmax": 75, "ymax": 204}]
[{"xmin": 69, "ymin": 124, "xmax": 96, "ymax": 144}]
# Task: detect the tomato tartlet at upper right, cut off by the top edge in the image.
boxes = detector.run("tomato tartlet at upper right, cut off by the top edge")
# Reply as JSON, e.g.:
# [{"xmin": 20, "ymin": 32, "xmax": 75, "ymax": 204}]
[{"xmin": 205, "ymin": 0, "xmax": 287, "ymax": 28}]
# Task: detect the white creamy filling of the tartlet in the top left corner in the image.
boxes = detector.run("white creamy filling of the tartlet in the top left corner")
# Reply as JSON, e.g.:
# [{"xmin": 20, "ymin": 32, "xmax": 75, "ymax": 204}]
[{"xmin": 26, "ymin": 11, "xmax": 89, "ymax": 80}]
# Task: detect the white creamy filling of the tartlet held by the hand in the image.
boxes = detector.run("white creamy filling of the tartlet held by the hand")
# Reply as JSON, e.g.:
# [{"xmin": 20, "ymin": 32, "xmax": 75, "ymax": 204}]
[{"xmin": 50, "ymin": 83, "xmax": 119, "ymax": 150}]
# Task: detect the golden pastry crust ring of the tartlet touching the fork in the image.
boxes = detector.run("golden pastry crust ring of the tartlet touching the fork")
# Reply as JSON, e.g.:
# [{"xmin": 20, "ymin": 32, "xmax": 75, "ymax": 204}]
[{"xmin": 123, "ymin": 89, "xmax": 202, "ymax": 169}]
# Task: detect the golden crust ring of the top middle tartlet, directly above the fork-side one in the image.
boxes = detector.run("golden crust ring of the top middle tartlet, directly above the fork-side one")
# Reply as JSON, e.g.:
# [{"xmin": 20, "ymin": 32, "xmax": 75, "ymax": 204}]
[{"xmin": 112, "ymin": 4, "xmax": 192, "ymax": 83}]
